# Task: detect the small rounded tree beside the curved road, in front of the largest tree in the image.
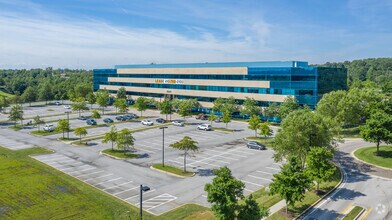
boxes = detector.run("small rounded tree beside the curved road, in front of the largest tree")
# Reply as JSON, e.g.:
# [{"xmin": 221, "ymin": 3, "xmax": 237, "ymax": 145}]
[{"xmin": 305, "ymin": 147, "xmax": 336, "ymax": 191}]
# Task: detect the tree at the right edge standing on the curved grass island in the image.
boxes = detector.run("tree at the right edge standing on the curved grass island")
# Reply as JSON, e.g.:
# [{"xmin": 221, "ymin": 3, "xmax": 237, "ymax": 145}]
[{"xmin": 360, "ymin": 109, "xmax": 392, "ymax": 155}]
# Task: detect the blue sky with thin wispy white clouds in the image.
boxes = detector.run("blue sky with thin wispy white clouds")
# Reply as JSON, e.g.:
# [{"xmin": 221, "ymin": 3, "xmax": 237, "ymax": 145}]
[{"xmin": 0, "ymin": 0, "xmax": 392, "ymax": 69}]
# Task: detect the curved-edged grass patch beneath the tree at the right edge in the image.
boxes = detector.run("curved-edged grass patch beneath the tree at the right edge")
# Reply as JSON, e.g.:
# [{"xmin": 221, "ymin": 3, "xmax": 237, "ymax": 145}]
[{"xmin": 354, "ymin": 146, "xmax": 392, "ymax": 168}]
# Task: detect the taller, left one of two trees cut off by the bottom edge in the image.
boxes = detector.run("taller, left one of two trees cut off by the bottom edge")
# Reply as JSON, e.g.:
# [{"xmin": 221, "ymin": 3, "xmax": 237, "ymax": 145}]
[{"xmin": 204, "ymin": 166, "xmax": 245, "ymax": 220}]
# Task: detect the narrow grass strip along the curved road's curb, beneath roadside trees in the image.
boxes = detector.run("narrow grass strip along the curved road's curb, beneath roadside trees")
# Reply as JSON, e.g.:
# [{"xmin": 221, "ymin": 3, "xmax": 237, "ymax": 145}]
[{"xmin": 267, "ymin": 168, "xmax": 341, "ymax": 220}]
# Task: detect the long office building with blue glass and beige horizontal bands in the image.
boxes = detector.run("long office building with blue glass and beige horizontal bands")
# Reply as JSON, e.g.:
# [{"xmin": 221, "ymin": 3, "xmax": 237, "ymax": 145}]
[{"xmin": 93, "ymin": 61, "xmax": 347, "ymax": 109}]
